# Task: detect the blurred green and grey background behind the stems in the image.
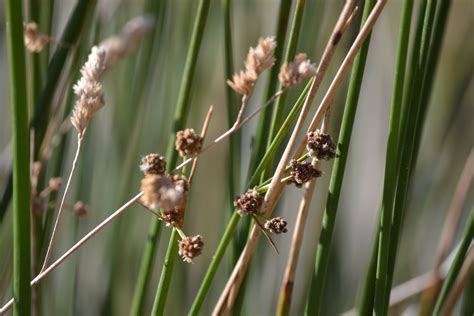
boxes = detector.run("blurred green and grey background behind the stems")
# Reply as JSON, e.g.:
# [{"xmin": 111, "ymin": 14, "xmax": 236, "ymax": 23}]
[{"xmin": 0, "ymin": 0, "xmax": 474, "ymax": 315}]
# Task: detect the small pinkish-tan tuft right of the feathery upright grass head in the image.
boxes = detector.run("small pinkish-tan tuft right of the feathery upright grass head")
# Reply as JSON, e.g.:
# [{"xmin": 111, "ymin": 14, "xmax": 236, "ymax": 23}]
[{"xmin": 278, "ymin": 53, "xmax": 316, "ymax": 88}]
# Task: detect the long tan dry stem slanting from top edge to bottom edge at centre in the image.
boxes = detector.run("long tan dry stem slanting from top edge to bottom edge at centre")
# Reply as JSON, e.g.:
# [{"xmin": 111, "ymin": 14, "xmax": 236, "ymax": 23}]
[{"xmin": 213, "ymin": 0, "xmax": 362, "ymax": 315}]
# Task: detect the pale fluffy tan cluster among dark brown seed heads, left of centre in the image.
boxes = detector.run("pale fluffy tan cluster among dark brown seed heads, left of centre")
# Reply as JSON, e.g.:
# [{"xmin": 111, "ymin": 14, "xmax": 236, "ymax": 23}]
[{"xmin": 141, "ymin": 174, "xmax": 187, "ymax": 213}]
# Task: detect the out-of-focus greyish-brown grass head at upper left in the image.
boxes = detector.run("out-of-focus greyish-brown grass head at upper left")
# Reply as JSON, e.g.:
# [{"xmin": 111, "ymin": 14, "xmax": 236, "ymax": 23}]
[{"xmin": 100, "ymin": 15, "xmax": 155, "ymax": 65}]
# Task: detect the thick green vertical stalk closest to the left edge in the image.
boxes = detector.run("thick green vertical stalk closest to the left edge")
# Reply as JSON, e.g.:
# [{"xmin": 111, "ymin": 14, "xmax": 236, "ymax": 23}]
[{"xmin": 5, "ymin": 0, "xmax": 31, "ymax": 316}]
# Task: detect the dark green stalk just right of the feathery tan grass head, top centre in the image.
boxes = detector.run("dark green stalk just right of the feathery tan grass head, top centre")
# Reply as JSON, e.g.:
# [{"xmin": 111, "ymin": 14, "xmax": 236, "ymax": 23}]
[{"xmin": 245, "ymin": 0, "xmax": 291, "ymax": 175}]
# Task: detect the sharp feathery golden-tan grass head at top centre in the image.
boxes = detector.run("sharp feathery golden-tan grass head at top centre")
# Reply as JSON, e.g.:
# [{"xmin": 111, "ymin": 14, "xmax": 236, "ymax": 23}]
[{"xmin": 227, "ymin": 37, "xmax": 276, "ymax": 96}]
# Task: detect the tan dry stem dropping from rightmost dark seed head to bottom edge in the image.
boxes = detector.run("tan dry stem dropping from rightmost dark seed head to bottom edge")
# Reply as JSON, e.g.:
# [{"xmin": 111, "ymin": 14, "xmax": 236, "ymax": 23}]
[{"xmin": 277, "ymin": 110, "xmax": 330, "ymax": 315}]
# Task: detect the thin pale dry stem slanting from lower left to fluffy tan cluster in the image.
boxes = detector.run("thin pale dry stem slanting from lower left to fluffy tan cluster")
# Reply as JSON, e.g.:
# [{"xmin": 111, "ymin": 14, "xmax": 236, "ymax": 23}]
[{"xmin": 0, "ymin": 192, "xmax": 143, "ymax": 315}]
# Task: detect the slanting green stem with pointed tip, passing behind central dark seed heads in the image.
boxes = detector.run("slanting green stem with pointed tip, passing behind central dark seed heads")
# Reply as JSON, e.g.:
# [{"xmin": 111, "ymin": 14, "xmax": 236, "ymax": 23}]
[{"xmin": 189, "ymin": 80, "xmax": 312, "ymax": 315}]
